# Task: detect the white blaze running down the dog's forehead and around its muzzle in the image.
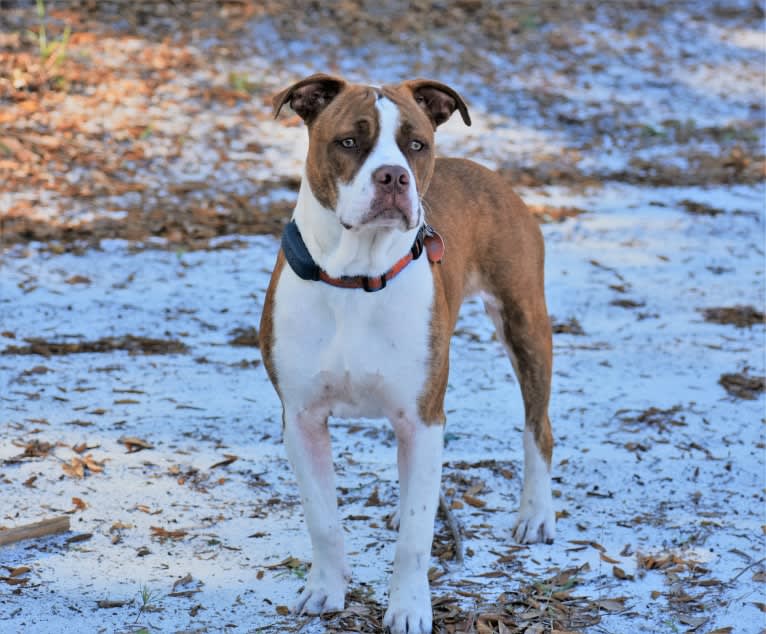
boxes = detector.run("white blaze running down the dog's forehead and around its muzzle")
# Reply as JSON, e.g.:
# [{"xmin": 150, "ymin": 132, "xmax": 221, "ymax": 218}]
[{"xmin": 336, "ymin": 97, "xmax": 419, "ymax": 227}]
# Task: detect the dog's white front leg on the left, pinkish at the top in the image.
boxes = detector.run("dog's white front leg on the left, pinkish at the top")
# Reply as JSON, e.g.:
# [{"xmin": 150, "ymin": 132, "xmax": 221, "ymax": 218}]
[{"xmin": 284, "ymin": 410, "xmax": 346, "ymax": 614}]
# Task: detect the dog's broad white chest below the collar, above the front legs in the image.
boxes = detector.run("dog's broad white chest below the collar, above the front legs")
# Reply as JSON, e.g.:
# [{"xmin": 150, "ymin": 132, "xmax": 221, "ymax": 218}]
[{"xmin": 273, "ymin": 258, "xmax": 433, "ymax": 418}]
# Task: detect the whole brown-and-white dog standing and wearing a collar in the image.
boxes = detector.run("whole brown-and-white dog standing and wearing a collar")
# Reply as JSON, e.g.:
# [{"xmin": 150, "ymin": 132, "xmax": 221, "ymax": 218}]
[{"xmin": 260, "ymin": 74, "xmax": 555, "ymax": 634}]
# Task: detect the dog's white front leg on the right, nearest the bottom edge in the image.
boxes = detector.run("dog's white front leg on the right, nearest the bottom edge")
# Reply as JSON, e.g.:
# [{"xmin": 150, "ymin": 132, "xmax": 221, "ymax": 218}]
[{"xmin": 383, "ymin": 418, "xmax": 443, "ymax": 634}]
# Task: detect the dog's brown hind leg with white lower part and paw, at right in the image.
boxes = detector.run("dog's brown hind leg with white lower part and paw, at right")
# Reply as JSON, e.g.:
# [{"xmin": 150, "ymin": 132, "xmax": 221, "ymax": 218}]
[{"xmin": 484, "ymin": 293, "xmax": 556, "ymax": 543}]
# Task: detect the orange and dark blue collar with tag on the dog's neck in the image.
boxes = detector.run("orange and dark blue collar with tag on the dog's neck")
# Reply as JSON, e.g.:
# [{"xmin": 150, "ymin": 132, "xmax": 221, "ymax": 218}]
[{"xmin": 282, "ymin": 220, "xmax": 444, "ymax": 293}]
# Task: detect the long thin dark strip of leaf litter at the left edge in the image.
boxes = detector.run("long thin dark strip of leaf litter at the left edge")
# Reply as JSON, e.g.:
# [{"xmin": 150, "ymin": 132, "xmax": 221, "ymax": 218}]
[{"xmin": 0, "ymin": 335, "xmax": 188, "ymax": 357}]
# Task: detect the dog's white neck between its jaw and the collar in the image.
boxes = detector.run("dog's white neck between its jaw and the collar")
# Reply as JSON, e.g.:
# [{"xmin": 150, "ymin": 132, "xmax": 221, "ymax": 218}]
[{"xmin": 293, "ymin": 174, "xmax": 423, "ymax": 277}]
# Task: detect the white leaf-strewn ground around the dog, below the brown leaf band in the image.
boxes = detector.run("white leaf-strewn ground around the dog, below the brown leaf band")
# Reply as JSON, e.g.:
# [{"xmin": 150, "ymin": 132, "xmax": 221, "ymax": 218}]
[{"xmin": 0, "ymin": 180, "xmax": 766, "ymax": 632}]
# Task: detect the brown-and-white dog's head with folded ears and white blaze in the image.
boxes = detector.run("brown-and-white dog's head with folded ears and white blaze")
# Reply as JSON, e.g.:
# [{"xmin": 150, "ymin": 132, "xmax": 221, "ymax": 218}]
[{"xmin": 274, "ymin": 74, "xmax": 471, "ymax": 231}]
